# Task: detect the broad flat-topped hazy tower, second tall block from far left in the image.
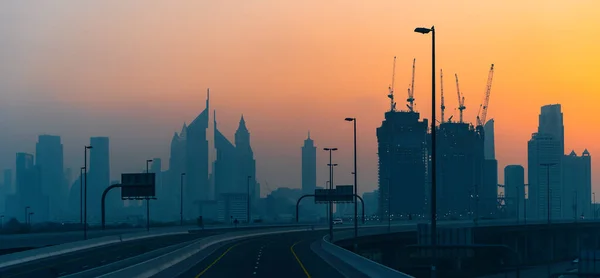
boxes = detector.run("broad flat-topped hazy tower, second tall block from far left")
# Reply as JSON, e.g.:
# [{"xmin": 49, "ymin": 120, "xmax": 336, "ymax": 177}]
[{"xmin": 35, "ymin": 135, "xmax": 68, "ymax": 219}]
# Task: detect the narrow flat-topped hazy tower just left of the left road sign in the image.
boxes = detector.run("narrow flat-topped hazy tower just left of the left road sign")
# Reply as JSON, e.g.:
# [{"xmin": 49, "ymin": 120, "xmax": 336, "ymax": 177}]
[{"xmin": 87, "ymin": 137, "xmax": 110, "ymax": 222}]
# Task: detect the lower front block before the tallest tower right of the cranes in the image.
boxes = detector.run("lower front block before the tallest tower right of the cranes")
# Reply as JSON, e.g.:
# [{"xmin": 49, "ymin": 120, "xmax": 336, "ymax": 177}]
[{"xmin": 527, "ymin": 133, "xmax": 564, "ymax": 220}]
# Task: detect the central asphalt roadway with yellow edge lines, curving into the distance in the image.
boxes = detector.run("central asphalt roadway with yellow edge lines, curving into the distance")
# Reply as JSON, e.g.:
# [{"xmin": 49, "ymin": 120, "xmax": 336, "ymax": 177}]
[{"xmin": 179, "ymin": 231, "xmax": 344, "ymax": 278}]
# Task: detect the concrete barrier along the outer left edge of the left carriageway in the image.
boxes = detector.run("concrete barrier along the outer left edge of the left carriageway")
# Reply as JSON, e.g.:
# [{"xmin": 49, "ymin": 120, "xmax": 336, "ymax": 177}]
[{"xmin": 0, "ymin": 231, "xmax": 188, "ymax": 269}]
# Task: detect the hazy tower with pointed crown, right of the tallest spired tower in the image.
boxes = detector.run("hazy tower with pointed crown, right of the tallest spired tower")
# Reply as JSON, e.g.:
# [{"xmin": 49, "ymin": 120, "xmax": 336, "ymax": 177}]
[{"xmin": 235, "ymin": 115, "xmax": 260, "ymax": 211}]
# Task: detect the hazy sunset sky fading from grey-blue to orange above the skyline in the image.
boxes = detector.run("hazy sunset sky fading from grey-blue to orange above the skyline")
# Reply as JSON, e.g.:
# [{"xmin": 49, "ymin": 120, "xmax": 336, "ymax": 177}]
[{"xmin": 0, "ymin": 0, "xmax": 600, "ymax": 195}]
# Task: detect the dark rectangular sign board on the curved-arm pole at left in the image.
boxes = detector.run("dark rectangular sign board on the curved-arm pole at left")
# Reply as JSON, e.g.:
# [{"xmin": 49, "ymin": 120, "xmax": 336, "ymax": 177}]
[{"xmin": 121, "ymin": 173, "xmax": 156, "ymax": 199}]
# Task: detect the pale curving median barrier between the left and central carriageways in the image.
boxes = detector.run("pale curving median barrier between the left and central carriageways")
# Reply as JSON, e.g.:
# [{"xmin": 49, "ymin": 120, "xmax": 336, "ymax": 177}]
[{"xmin": 99, "ymin": 227, "xmax": 317, "ymax": 278}]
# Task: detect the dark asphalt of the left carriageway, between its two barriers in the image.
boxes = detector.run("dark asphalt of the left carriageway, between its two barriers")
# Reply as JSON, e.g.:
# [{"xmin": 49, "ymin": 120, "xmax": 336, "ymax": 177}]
[{"xmin": 0, "ymin": 233, "xmax": 209, "ymax": 278}]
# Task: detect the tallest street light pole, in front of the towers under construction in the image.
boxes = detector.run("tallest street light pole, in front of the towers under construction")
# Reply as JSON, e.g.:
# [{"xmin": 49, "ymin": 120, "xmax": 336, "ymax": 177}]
[{"xmin": 415, "ymin": 26, "xmax": 437, "ymax": 277}]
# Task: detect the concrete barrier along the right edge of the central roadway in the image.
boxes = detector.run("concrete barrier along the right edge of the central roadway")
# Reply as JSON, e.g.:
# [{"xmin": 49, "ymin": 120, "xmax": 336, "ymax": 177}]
[{"xmin": 321, "ymin": 235, "xmax": 414, "ymax": 278}]
